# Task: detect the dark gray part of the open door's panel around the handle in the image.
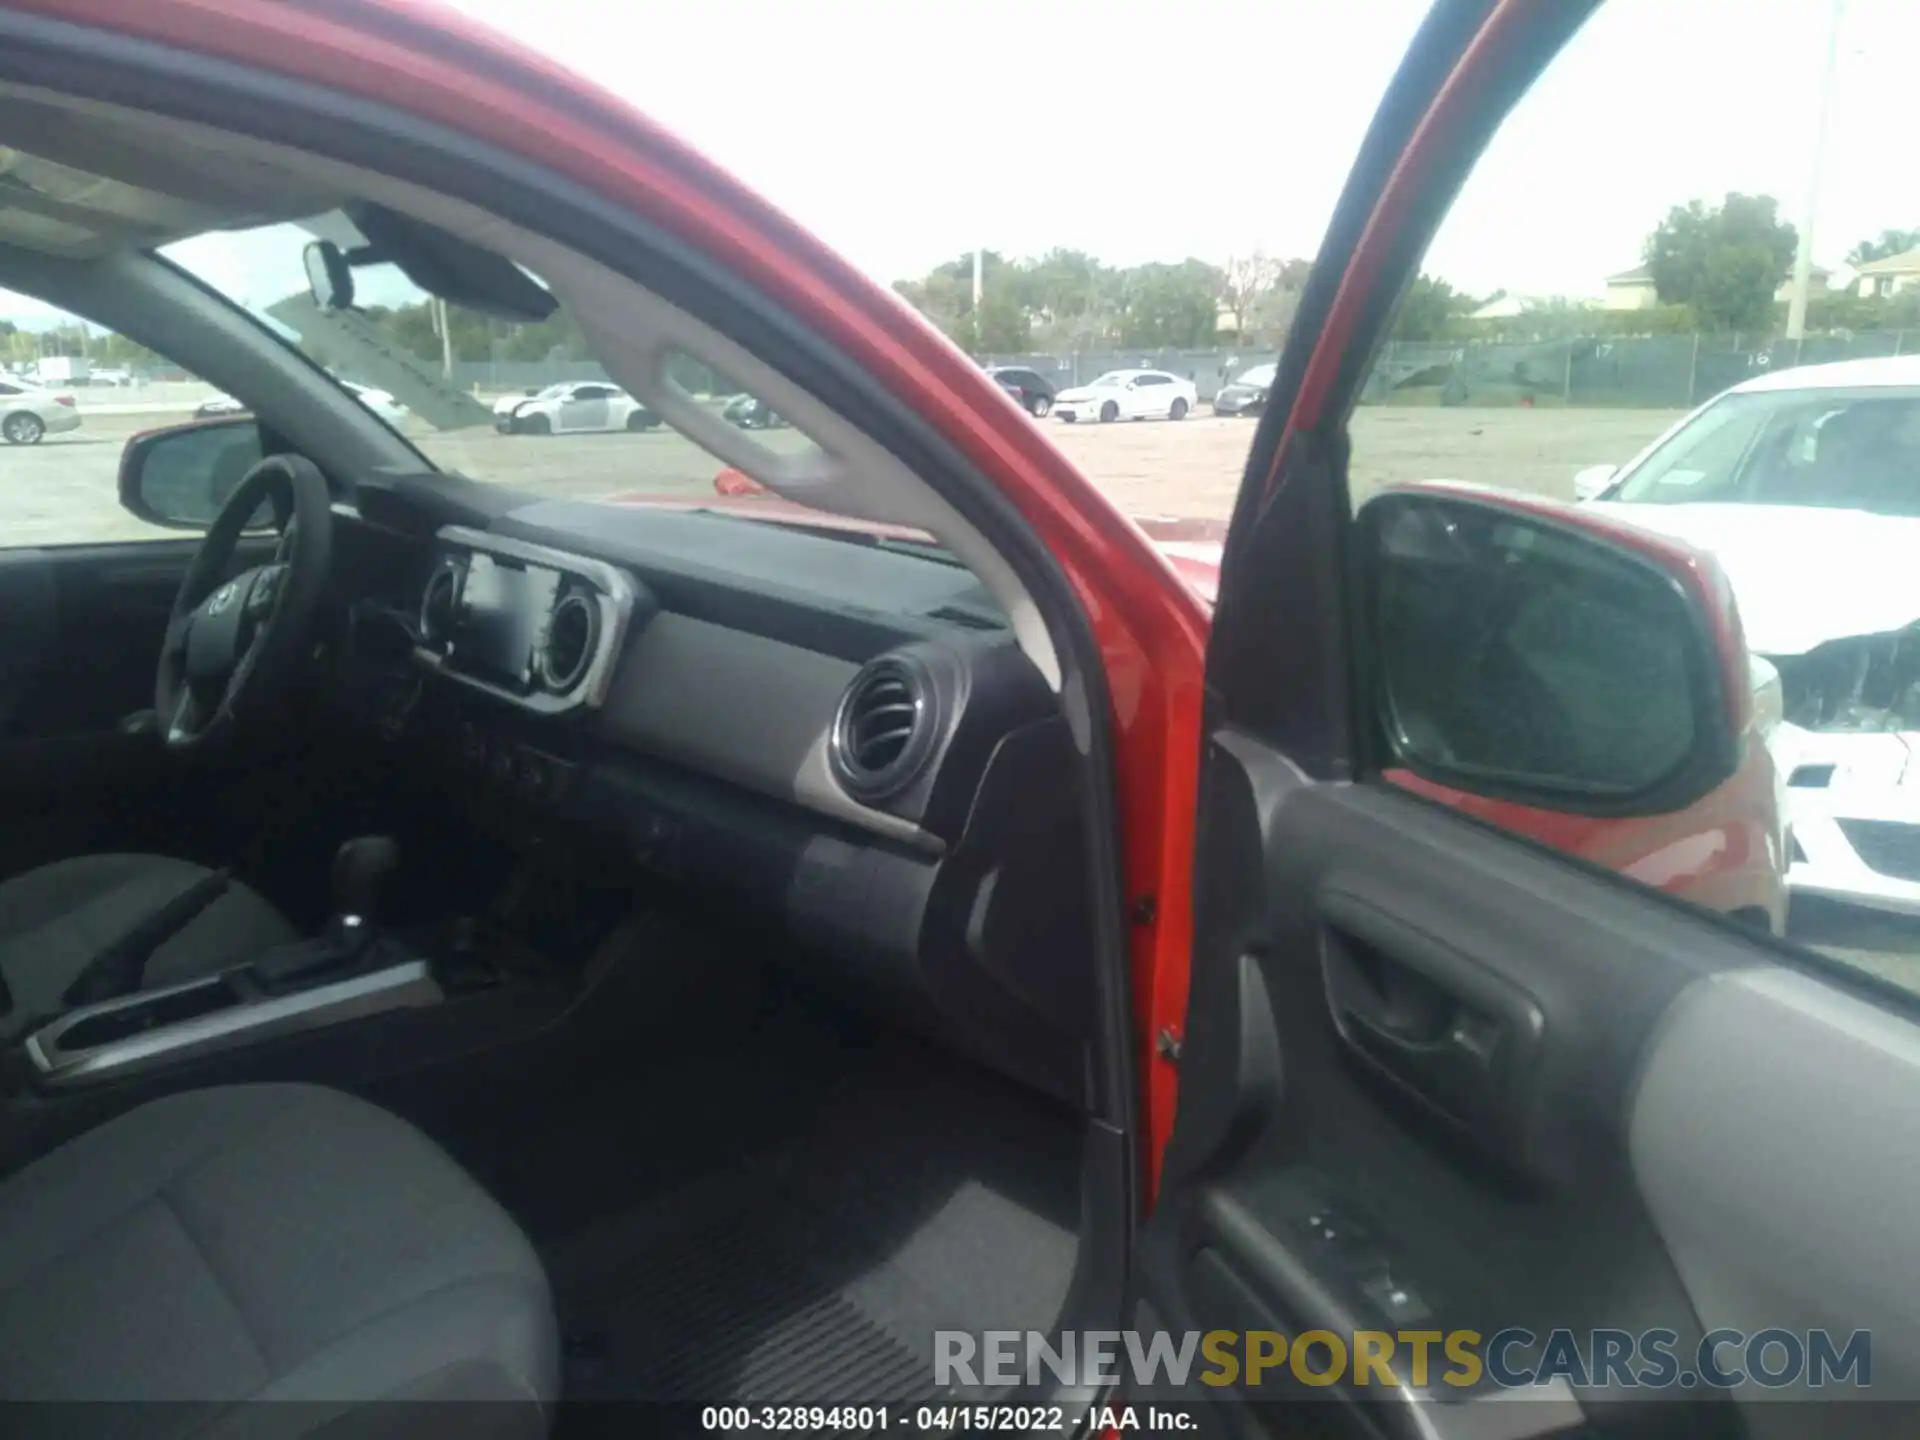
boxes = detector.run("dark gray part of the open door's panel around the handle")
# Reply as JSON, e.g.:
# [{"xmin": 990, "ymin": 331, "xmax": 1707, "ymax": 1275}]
[{"xmin": 1140, "ymin": 732, "xmax": 1759, "ymax": 1434}]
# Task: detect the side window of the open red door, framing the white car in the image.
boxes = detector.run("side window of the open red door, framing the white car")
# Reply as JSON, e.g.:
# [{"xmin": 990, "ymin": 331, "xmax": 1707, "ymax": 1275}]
[{"xmin": 1350, "ymin": 0, "xmax": 1920, "ymax": 991}]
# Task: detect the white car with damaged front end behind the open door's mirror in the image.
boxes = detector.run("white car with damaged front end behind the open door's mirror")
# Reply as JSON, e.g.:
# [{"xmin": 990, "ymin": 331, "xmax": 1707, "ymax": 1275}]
[{"xmin": 1576, "ymin": 357, "xmax": 1920, "ymax": 916}]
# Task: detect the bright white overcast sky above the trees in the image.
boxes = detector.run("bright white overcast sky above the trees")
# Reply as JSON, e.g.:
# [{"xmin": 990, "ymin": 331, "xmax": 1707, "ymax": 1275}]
[{"xmin": 11, "ymin": 0, "xmax": 1920, "ymax": 330}]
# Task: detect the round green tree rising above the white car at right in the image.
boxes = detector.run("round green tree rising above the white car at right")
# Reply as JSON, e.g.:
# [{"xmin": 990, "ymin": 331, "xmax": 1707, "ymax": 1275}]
[{"xmin": 1642, "ymin": 192, "xmax": 1799, "ymax": 330}]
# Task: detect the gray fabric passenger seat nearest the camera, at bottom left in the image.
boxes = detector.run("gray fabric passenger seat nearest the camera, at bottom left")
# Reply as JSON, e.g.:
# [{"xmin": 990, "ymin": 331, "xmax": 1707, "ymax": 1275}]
[{"xmin": 0, "ymin": 1085, "xmax": 559, "ymax": 1436}]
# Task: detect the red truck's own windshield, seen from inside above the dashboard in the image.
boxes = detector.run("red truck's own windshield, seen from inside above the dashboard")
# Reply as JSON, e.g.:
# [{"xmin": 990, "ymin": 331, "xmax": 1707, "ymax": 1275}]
[{"xmin": 147, "ymin": 211, "xmax": 913, "ymax": 545}]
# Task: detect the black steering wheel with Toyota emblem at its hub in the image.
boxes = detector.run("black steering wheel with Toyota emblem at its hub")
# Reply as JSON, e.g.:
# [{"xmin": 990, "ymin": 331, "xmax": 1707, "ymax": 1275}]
[{"xmin": 154, "ymin": 455, "xmax": 334, "ymax": 751}]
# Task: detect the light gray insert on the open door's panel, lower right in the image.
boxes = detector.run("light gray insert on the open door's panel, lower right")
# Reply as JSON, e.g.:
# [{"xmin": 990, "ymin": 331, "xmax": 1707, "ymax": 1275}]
[{"xmin": 1628, "ymin": 970, "xmax": 1920, "ymax": 1434}]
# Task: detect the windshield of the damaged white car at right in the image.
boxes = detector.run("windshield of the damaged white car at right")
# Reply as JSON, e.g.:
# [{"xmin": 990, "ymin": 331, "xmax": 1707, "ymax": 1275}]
[{"xmin": 1607, "ymin": 390, "xmax": 1920, "ymax": 516}]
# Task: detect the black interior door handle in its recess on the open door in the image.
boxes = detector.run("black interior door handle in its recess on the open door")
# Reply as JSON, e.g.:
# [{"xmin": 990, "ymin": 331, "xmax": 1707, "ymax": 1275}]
[{"xmin": 1319, "ymin": 889, "xmax": 1546, "ymax": 1137}]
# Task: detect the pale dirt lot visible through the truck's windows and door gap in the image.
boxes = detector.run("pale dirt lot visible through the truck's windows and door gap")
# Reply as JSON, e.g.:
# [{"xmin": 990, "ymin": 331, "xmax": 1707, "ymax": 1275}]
[{"xmin": 11, "ymin": 407, "xmax": 1676, "ymax": 545}]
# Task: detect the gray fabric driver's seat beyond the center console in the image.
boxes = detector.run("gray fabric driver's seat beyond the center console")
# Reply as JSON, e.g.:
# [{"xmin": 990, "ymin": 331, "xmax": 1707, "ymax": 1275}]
[{"xmin": 0, "ymin": 854, "xmax": 300, "ymax": 1039}]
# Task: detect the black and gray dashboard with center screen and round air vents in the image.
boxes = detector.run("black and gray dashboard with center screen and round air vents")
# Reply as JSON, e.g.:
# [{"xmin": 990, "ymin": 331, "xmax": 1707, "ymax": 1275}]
[{"xmin": 340, "ymin": 478, "xmax": 1094, "ymax": 1098}]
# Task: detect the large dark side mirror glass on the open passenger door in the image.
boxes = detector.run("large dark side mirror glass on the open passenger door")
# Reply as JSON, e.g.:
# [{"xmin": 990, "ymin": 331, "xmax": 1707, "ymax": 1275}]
[{"xmin": 1356, "ymin": 484, "xmax": 1753, "ymax": 816}]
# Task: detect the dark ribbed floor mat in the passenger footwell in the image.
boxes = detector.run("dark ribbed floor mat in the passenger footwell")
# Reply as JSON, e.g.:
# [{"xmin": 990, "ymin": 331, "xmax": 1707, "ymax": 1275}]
[{"xmin": 541, "ymin": 1013, "xmax": 1081, "ymax": 1405}]
